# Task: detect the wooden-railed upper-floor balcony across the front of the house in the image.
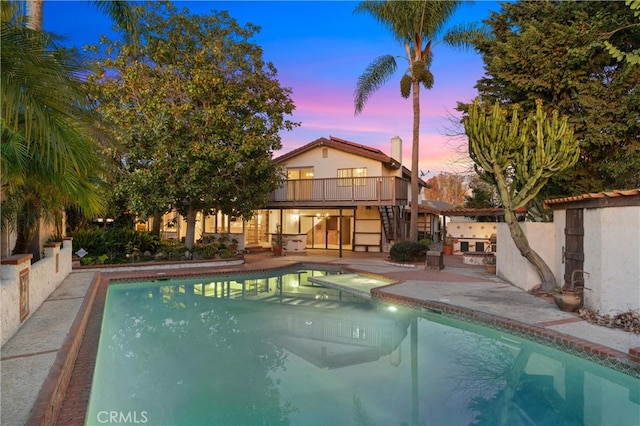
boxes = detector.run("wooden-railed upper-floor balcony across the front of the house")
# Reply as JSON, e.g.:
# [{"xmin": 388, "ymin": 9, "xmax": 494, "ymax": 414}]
[{"xmin": 267, "ymin": 176, "xmax": 410, "ymax": 208}]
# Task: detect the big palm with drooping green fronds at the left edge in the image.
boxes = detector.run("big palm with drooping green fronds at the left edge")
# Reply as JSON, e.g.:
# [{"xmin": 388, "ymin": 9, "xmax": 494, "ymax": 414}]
[{"xmin": 0, "ymin": 3, "xmax": 102, "ymax": 253}]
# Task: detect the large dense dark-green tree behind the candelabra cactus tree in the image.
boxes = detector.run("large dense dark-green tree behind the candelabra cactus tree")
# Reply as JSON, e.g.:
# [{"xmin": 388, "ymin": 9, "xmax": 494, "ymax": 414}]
[{"xmin": 458, "ymin": 1, "xmax": 640, "ymax": 197}]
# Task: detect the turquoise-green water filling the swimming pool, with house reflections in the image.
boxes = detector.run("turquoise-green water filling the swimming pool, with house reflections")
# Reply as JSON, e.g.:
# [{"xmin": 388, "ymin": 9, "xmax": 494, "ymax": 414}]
[{"xmin": 86, "ymin": 270, "xmax": 640, "ymax": 425}]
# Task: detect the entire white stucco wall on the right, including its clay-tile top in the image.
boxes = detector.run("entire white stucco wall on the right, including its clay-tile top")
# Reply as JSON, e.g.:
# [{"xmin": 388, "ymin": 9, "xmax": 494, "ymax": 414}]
[{"xmin": 470, "ymin": 189, "xmax": 640, "ymax": 316}]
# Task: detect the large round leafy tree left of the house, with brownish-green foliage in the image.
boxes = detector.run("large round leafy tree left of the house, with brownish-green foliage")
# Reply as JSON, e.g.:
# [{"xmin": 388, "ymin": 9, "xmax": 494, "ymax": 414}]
[{"xmin": 89, "ymin": 3, "xmax": 295, "ymax": 249}]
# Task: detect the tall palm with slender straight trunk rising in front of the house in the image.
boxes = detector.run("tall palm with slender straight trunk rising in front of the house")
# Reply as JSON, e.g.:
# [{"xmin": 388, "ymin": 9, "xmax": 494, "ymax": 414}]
[{"xmin": 354, "ymin": 1, "xmax": 460, "ymax": 241}]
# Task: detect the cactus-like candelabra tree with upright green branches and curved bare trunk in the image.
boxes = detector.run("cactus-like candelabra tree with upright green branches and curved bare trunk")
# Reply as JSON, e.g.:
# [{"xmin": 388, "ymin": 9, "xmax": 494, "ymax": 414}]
[{"xmin": 463, "ymin": 99, "xmax": 580, "ymax": 292}]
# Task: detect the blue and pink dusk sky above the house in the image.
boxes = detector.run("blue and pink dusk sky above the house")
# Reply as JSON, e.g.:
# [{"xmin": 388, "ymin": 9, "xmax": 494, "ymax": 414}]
[{"xmin": 44, "ymin": 0, "xmax": 499, "ymax": 175}]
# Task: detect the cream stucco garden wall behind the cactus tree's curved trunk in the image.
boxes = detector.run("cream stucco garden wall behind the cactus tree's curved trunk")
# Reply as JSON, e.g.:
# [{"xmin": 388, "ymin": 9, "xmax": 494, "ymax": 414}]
[{"xmin": 496, "ymin": 222, "xmax": 559, "ymax": 291}]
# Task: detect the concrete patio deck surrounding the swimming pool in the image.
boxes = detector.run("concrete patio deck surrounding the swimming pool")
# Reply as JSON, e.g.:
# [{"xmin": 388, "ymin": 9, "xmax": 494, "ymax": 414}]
[{"xmin": 0, "ymin": 250, "xmax": 640, "ymax": 426}]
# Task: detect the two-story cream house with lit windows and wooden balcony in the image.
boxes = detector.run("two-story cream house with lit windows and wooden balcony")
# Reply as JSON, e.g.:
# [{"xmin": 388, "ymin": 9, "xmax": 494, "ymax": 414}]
[{"xmin": 150, "ymin": 136, "xmax": 438, "ymax": 252}]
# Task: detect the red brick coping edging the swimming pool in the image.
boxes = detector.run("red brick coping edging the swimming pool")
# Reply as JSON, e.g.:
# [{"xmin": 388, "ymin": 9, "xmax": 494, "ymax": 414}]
[{"xmin": 26, "ymin": 261, "xmax": 640, "ymax": 426}]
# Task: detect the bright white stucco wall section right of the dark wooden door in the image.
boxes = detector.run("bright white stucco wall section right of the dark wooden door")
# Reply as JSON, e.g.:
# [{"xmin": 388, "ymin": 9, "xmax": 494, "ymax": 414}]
[{"xmin": 584, "ymin": 206, "xmax": 640, "ymax": 315}]
